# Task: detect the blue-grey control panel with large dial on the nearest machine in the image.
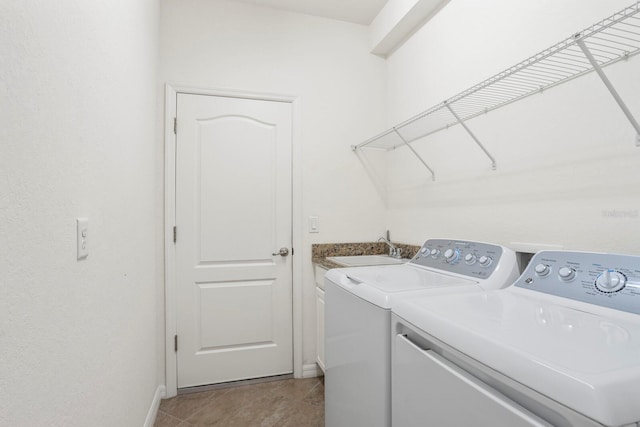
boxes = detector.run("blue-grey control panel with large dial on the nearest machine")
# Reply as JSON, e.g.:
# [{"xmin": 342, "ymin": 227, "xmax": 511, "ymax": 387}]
[{"xmin": 514, "ymin": 251, "xmax": 640, "ymax": 314}]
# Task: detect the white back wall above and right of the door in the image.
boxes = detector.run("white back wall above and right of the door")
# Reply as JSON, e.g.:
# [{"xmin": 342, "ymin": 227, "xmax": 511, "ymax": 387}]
[{"xmin": 160, "ymin": 0, "xmax": 385, "ymax": 378}]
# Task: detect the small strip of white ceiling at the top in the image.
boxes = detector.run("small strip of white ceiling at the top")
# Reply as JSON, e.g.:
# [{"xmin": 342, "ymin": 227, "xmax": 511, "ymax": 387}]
[{"xmin": 232, "ymin": 0, "xmax": 387, "ymax": 25}]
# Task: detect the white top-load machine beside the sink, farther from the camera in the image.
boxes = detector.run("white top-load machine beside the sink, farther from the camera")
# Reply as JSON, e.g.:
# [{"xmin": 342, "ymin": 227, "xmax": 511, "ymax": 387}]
[{"xmin": 325, "ymin": 239, "xmax": 518, "ymax": 427}]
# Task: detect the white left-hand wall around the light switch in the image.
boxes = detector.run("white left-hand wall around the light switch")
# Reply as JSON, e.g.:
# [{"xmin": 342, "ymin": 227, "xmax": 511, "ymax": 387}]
[{"xmin": 0, "ymin": 0, "xmax": 161, "ymax": 427}]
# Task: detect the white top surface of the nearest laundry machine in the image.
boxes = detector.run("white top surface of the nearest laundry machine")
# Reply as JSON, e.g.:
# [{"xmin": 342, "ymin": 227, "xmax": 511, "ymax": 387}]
[{"xmin": 394, "ymin": 288, "xmax": 640, "ymax": 426}]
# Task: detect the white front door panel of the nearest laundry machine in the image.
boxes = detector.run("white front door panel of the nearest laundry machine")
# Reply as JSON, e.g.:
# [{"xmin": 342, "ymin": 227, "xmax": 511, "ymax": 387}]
[{"xmin": 391, "ymin": 335, "xmax": 551, "ymax": 427}]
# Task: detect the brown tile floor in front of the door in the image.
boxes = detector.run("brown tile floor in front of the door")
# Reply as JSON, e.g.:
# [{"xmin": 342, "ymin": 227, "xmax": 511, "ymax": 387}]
[{"xmin": 155, "ymin": 378, "xmax": 324, "ymax": 427}]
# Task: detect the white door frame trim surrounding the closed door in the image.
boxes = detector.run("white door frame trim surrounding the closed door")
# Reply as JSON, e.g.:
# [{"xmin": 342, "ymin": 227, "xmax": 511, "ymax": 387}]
[{"xmin": 164, "ymin": 84, "xmax": 303, "ymax": 397}]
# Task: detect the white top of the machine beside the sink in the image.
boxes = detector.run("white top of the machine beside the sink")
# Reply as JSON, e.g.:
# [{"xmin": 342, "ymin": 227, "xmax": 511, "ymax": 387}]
[{"xmin": 325, "ymin": 264, "xmax": 481, "ymax": 309}]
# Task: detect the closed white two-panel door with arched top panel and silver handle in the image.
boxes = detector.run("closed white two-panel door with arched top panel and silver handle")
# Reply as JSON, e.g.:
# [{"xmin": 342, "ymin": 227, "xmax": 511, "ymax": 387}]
[{"xmin": 176, "ymin": 94, "xmax": 293, "ymax": 388}]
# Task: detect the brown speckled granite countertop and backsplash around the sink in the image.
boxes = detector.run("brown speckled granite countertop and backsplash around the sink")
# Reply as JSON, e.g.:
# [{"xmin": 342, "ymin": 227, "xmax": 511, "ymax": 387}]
[{"xmin": 311, "ymin": 242, "xmax": 420, "ymax": 269}]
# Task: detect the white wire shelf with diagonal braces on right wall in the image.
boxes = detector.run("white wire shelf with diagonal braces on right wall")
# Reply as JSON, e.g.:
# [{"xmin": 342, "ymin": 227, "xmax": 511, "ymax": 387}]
[{"xmin": 352, "ymin": 1, "xmax": 640, "ymax": 155}]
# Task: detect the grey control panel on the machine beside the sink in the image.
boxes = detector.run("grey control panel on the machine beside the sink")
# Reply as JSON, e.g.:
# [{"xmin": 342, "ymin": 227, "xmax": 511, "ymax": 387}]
[{"xmin": 411, "ymin": 239, "xmax": 502, "ymax": 279}]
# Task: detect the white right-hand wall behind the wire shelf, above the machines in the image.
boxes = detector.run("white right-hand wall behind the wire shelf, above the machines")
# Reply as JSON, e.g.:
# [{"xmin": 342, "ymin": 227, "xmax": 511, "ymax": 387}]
[{"xmin": 379, "ymin": 0, "xmax": 640, "ymax": 254}]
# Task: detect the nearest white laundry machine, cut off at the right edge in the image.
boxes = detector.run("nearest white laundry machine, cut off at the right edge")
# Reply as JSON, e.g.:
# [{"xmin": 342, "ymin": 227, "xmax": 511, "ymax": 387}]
[{"xmin": 392, "ymin": 251, "xmax": 640, "ymax": 427}]
